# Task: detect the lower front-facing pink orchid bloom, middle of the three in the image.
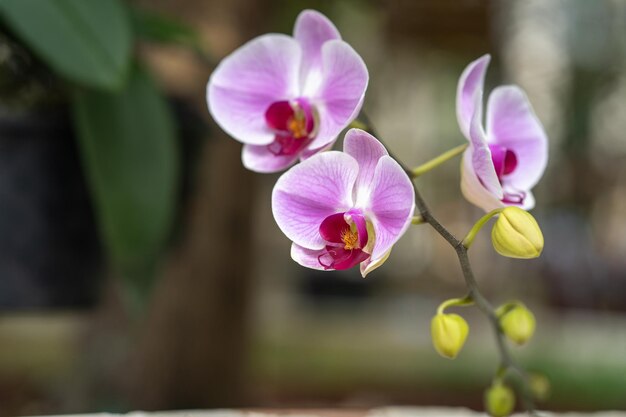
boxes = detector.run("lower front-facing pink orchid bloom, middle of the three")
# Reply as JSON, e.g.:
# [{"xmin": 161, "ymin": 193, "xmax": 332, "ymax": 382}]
[{"xmin": 272, "ymin": 129, "xmax": 415, "ymax": 276}]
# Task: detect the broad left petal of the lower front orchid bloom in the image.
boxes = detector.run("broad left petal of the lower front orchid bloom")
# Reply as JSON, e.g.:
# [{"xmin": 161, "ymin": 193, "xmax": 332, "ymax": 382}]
[{"xmin": 272, "ymin": 151, "xmax": 359, "ymax": 249}]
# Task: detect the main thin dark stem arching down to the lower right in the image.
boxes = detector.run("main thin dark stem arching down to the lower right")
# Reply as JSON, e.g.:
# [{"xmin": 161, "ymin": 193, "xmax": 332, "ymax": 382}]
[{"xmin": 361, "ymin": 111, "xmax": 537, "ymax": 416}]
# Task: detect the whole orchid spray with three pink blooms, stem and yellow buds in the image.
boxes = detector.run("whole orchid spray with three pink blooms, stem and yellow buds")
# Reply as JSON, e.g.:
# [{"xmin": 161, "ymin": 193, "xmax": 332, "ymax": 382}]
[{"xmin": 207, "ymin": 10, "xmax": 547, "ymax": 416}]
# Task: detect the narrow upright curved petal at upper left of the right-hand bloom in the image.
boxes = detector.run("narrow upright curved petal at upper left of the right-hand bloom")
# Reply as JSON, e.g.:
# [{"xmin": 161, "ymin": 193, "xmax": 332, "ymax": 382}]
[{"xmin": 456, "ymin": 55, "xmax": 491, "ymax": 139}]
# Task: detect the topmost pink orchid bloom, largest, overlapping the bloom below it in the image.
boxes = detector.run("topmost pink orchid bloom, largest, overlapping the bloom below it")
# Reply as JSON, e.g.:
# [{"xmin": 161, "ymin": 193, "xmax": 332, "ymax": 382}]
[{"xmin": 207, "ymin": 10, "xmax": 368, "ymax": 172}]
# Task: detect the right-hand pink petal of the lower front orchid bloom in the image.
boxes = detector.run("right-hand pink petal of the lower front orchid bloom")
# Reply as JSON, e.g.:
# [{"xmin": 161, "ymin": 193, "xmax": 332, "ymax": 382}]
[{"xmin": 364, "ymin": 155, "xmax": 415, "ymax": 262}]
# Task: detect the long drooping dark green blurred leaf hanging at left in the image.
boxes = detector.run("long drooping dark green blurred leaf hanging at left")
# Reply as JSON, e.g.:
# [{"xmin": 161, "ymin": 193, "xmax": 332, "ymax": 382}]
[{"xmin": 73, "ymin": 69, "xmax": 179, "ymax": 296}]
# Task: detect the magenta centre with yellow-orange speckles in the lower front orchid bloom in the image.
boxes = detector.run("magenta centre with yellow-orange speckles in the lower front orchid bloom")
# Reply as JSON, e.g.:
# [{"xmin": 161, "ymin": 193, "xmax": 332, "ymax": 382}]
[{"xmin": 317, "ymin": 210, "xmax": 371, "ymax": 270}]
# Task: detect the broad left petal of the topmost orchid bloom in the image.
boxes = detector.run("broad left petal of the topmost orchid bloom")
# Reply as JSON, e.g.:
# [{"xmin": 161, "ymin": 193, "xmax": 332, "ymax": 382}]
[{"xmin": 207, "ymin": 34, "xmax": 302, "ymax": 145}]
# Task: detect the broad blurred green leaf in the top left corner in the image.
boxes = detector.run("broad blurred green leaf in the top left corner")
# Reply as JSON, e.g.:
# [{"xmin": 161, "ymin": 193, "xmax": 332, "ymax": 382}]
[{"xmin": 0, "ymin": 0, "xmax": 132, "ymax": 89}]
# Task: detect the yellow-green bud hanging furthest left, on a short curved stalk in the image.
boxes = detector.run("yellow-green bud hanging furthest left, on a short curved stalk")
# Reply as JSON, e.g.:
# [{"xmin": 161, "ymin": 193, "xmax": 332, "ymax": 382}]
[{"xmin": 430, "ymin": 313, "xmax": 469, "ymax": 359}]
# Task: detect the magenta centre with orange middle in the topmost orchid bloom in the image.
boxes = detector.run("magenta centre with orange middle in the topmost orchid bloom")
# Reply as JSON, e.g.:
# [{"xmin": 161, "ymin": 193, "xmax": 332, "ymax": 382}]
[{"xmin": 265, "ymin": 98, "xmax": 315, "ymax": 156}]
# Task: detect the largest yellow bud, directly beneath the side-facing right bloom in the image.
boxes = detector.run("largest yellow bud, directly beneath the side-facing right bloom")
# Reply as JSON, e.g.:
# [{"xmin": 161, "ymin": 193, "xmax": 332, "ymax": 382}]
[{"xmin": 491, "ymin": 207, "xmax": 543, "ymax": 259}]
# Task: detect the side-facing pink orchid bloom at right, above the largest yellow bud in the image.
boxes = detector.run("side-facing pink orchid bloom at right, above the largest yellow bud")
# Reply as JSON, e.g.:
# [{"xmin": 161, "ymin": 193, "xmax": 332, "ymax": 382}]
[{"xmin": 456, "ymin": 55, "xmax": 548, "ymax": 211}]
